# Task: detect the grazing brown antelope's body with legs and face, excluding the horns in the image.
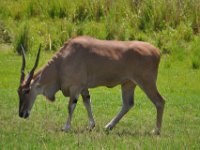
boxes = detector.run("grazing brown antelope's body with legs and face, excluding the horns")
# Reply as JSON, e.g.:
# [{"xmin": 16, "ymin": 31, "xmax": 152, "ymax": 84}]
[{"xmin": 19, "ymin": 36, "xmax": 164, "ymax": 134}]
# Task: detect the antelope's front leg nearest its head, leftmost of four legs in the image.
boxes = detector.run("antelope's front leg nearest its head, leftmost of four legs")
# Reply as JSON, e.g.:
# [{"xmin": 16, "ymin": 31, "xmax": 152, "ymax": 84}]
[{"xmin": 62, "ymin": 97, "xmax": 78, "ymax": 131}]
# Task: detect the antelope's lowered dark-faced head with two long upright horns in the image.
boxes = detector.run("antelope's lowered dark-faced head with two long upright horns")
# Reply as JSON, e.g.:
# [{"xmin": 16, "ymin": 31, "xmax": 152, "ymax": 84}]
[{"xmin": 18, "ymin": 44, "xmax": 41, "ymax": 118}]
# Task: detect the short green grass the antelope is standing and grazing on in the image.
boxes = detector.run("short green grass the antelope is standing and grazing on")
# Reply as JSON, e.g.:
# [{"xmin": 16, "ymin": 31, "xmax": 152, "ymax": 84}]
[{"xmin": 0, "ymin": 45, "xmax": 200, "ymax": 149}]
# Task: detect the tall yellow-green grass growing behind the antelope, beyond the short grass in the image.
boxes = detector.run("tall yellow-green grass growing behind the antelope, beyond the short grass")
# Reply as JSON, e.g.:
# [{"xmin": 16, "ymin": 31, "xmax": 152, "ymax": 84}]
[{"xmin": 0, "ymin": 0, "xmax": 200, "ymax": 67}]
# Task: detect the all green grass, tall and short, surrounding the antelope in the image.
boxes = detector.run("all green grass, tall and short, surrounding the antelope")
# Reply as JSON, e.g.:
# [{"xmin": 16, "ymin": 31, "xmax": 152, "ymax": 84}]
[{"xmin": 0, "ymin": 0, "xmax": 200, "ymax": 149}]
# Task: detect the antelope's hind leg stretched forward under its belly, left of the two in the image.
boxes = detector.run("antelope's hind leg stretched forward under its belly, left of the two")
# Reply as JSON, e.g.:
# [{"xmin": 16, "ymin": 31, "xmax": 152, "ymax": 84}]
[{"xmin": 105, "ymin": 81, "xmax": 136, "ymax": 130}]
